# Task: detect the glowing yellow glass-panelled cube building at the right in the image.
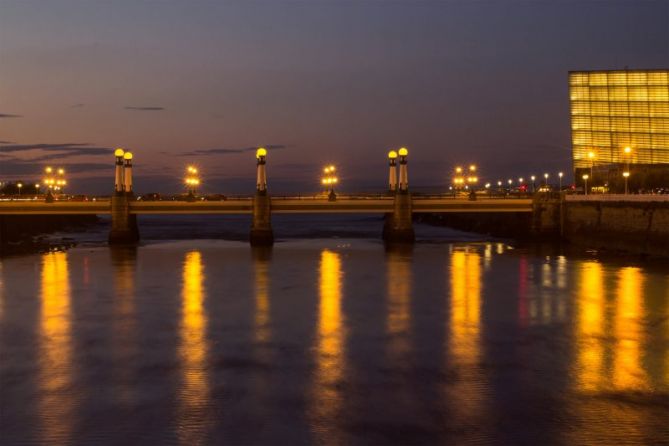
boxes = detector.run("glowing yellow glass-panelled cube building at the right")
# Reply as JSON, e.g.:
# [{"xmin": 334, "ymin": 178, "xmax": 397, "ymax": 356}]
[{"xmin": 569, "ymin": 70, "xmax": 669, "ymax": 190}]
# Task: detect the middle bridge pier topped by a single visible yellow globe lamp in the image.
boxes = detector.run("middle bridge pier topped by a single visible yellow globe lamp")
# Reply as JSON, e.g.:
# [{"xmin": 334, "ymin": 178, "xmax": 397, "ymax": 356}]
[{"xmin": 249, "ymin": 147, "xmax": 274, "ymax": 246}]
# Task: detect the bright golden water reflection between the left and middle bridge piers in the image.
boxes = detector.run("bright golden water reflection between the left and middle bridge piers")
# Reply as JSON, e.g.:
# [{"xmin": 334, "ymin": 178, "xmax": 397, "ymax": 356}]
[{"xmin": 177, "ymin": 251, "xmax": 209, "ymax": 445}]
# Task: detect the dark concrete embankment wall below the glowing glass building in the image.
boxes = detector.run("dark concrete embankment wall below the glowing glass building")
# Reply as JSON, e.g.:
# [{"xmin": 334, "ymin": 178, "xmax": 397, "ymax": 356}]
[{"xmin": 562, "ymin": 195, "xmax": 669, "ymax": 257}]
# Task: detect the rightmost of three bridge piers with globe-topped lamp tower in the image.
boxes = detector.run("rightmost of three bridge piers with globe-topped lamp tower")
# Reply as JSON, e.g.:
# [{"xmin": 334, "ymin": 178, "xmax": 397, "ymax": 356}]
[{"xmin": 383, "ymin": 147, "xmax": 416, "ymax": 244}]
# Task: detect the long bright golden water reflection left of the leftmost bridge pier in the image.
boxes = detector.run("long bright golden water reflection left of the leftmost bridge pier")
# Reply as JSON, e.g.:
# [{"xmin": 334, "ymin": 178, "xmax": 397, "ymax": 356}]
[{"xmin": 38, "ymin": 252, "xmax": 73, "ymax": 444}]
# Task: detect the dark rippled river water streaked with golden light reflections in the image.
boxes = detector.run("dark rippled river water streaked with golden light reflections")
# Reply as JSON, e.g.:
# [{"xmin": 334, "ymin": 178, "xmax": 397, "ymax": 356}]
[{"xmin": 0, "ymin": 217, "xmax": 669, "ymax": 445}]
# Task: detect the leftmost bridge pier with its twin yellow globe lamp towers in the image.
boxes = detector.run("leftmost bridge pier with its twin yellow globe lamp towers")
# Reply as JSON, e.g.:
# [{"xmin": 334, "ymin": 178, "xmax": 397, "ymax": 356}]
[{"xmin": 108, "ymin": 149, "xmax": 139, "ymax": 245}]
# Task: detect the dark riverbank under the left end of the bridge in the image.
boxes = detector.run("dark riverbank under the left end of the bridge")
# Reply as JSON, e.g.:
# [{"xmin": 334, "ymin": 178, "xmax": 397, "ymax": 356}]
[{"xmin": 0, "ymin": 215, "xmax": 99, "ymax": 256}]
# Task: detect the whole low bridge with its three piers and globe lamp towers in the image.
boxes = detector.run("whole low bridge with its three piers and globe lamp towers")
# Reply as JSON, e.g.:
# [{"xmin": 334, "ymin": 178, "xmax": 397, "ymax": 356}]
[{"xmin": 0, "ymin": 148, "xmax": 533, "ymax": 245}]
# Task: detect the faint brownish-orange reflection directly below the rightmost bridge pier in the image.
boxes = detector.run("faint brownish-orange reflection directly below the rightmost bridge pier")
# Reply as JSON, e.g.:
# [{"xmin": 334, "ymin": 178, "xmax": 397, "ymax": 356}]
[{"xmin": 386, "ymin": 246, "xmax": 411, "ymax": 358}]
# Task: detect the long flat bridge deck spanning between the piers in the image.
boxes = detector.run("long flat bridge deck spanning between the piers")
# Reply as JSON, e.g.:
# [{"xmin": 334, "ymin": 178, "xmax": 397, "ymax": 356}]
[{"xmin": 0, "ymin": 197, "xmax": 532, "ymax": 215}]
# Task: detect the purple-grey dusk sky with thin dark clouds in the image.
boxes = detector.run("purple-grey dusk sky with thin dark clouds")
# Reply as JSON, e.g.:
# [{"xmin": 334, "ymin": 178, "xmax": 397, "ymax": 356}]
[{"xmin": 0, "ymin": 0, "xmax": 669, "ymax": 193}]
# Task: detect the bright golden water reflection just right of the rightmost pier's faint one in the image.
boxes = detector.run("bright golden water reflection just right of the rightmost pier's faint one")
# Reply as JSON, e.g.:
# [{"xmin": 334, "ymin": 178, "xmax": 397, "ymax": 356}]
[{"xmin": 447, "ymin": 249, "xmax": 485, "ymax": 420}]
